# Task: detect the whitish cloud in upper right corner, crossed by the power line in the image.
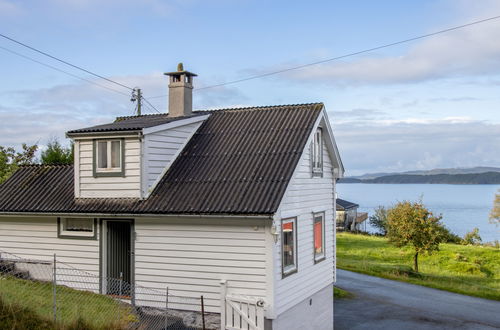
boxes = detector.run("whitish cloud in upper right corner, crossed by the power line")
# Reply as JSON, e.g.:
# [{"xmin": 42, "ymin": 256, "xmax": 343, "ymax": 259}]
[{"xmin": 278, "ymin": 1, "xmax": 500, "ymax": 84}]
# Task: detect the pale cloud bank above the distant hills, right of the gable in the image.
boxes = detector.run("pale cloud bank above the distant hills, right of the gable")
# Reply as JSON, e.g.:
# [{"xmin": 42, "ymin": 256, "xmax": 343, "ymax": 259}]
[{"xmin": 333, "ymin": 117, "xmax": 500, "ymax": 175}]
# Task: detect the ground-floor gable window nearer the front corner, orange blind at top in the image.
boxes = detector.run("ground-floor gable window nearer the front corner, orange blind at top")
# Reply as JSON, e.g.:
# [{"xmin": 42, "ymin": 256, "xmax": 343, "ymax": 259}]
[{"xmin": 281, "ymin": 218, "xmax": 297, "ymax": 277}]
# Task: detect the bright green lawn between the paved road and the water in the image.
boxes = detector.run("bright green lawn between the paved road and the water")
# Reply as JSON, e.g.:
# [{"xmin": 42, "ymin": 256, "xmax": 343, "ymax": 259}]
[{"xmin": 337, "ymin": 233, "xmax": 500, "ymax": 300}]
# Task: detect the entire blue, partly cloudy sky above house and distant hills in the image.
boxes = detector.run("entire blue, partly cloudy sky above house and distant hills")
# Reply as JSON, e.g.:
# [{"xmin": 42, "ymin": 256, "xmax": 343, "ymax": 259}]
[{"xmin": 0, "ymin": 0, "xmax": 500, "ymax": 175}]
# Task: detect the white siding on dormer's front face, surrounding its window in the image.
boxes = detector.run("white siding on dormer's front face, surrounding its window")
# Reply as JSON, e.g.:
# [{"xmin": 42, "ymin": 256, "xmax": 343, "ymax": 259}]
[{"xmin": 75, "ymin": 137, "xmax": 141, "ymax": 198}]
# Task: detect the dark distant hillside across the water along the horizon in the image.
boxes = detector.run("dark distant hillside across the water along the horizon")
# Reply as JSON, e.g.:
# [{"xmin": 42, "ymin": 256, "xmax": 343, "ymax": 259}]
[{"xmin": 339, "ymin": 172, "xmax": 500, "ymax": 184}]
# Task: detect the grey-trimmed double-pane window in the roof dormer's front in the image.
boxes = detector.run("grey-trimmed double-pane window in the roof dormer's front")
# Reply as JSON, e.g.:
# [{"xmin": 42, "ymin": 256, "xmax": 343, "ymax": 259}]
[{"xmin": 93, "ymin": 139, "xmax": 125, "ymax": 177}]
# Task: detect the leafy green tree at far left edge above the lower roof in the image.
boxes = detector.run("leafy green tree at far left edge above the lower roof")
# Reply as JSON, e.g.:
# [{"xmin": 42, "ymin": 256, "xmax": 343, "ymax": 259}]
[{"xmin": 0, "ymin": 143, "xmax": 38, "ymax": 183}]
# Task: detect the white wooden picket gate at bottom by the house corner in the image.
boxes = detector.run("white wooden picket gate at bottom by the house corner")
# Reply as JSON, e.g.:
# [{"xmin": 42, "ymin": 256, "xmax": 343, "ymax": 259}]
[{"xmin": 221, "ymin": 282, "xmax": 264, "ymax": 330}]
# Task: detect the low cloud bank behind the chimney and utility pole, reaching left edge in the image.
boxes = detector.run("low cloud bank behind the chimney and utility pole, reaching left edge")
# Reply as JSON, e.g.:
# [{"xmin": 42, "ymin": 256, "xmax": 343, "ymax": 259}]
[{"xmin": 0, "ymin": 72, "xmax": 246, "ymax": 146}]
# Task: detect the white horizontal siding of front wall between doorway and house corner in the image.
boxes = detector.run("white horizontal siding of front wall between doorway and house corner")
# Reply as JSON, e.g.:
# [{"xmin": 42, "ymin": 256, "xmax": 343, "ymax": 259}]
[{"xmin": 135, "ymin": 218, "xmax": 267, "ymax": 313}]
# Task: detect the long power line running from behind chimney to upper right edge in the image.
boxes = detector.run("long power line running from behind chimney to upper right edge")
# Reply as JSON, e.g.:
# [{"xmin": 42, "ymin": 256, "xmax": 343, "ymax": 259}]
[{"xmin": 150, "ymin": 15, "xmax": 500, "ymax": 99}]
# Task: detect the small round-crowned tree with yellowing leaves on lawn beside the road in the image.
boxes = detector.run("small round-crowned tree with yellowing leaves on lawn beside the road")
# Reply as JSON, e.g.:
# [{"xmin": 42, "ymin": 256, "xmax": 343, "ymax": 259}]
[{"xmin": 387, "ymin": 201, "xmax": 446, "ymax": 272}]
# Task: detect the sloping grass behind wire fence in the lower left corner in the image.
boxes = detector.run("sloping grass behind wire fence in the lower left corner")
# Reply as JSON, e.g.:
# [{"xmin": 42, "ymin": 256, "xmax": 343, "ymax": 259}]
[{"xmin": 0, "ymin": 277, "xmax": 134, "ymax": 329}]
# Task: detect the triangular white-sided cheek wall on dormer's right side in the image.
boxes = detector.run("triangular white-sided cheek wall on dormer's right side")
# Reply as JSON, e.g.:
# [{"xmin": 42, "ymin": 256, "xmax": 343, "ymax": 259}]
[{"xmin": 143, "ymin": 122, "xmax": 202, "ymax": 196}]
